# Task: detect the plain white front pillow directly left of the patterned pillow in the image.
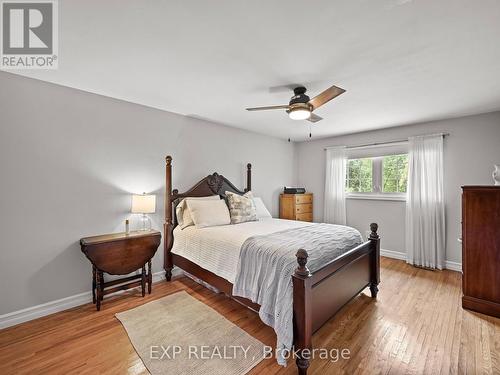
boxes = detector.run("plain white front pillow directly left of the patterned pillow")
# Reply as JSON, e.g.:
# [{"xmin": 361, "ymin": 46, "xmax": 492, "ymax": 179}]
[{"xmin": 187, "ymin": 199, "xmax": 231, "ymax": 228}]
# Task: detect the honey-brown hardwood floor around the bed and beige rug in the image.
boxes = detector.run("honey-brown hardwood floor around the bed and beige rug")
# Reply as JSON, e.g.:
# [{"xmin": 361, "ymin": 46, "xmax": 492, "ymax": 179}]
[{"xmin": 0, "ymin": 258, "xmax": 500, "ymax": 375}]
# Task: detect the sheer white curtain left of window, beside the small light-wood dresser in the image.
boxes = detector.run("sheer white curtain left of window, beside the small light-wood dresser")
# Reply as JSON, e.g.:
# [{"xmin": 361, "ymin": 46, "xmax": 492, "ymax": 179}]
[{"xmin": 324, "ymin": 147, "xmax": 347, "ymax": 225}]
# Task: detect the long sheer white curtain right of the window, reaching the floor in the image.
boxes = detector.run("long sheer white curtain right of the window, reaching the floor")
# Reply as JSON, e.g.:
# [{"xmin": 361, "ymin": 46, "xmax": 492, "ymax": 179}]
[{"xmin": 406, "ymin": 135, "xmax": 446, "ymax": 269}]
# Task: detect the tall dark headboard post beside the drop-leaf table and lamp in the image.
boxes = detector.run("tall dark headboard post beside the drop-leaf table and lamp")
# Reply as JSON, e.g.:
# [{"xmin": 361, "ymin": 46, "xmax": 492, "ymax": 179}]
[{"xmin": 163, "ymin": 155, "xmax": 174, "ymax": 281}]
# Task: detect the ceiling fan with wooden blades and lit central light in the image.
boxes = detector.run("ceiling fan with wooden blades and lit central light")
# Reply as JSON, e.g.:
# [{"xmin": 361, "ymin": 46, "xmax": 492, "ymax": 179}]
[{"xmin": 247, "ymin": 86, "xmax": 345, "ymax": 122}]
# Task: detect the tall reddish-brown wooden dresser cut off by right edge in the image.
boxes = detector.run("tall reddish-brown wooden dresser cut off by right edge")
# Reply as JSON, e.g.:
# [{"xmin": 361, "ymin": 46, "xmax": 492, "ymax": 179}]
[{"xmin": 462, "ymin": 186, "xmax": 500, "ymax": 317}]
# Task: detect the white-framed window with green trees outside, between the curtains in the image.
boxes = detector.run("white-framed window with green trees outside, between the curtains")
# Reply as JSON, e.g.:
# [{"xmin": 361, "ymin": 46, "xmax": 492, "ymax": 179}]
[{"xmin": 346, "ymin": 154, "xmax": 408, "ymax": 200}]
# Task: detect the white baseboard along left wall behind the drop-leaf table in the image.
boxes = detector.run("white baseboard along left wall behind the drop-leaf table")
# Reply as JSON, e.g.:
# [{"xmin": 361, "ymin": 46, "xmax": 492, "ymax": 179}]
[{"xmin": 0, "ymin": 268, "xmax": 182, "ymax": 329}]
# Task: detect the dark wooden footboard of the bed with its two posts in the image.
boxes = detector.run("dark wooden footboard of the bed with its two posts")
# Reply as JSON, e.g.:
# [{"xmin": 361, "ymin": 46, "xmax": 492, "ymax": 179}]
[{"xmin": 292, "ymin": 223, "xmax": 380, "ymax": 374}]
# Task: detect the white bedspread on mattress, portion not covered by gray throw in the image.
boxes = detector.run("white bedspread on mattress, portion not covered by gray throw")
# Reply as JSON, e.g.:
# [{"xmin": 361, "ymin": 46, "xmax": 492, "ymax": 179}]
[{"xmin": 172, "ymin": 218, "xmax": 313, "ymax": 284}]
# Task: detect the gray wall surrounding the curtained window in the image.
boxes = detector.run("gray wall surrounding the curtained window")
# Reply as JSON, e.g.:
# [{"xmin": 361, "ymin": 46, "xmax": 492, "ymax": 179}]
[{"xmin": 296, "ymin": 112, "xmax": 500, "ymax": 262}]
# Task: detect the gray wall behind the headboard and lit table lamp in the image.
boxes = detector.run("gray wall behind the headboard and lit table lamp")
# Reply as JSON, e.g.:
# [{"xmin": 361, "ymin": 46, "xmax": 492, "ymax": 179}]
[{"xmin": 0, "ymin": 72, "xmax": 296, "ymax": 314}]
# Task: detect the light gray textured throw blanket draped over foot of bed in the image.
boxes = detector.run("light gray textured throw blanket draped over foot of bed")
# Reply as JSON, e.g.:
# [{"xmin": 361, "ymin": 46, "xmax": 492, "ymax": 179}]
[{"xmin": 233, "ymin": 224, "xmax": 363, "ymax": 365}]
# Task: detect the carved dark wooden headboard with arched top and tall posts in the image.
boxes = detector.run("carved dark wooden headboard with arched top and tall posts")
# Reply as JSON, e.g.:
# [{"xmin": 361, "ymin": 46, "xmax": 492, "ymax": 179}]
[{"xmin": 163, "ymin": 156, "xmax": 252, "ymax": 276}]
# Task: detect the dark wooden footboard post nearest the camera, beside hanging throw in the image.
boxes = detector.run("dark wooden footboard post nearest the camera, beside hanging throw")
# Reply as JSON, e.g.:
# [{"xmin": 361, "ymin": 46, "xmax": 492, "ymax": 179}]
[{"xmin": 292, "ymin": 249, "xmax": 312, "ymax": 375}]
